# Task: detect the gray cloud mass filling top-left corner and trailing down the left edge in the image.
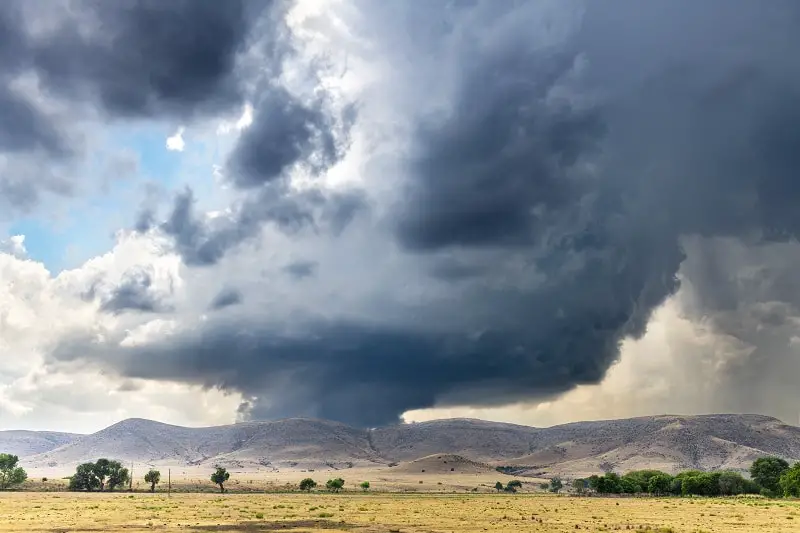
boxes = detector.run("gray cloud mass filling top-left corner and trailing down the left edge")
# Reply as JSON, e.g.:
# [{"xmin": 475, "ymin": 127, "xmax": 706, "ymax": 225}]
[{"xmin": 0, "ymin": 0, "xmax": 278, "ymax": 208}]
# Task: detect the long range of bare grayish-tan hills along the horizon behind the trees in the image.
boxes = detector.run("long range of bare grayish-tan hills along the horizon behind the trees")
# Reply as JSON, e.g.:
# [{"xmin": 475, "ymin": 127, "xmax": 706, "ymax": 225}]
[{"xmin": 12, "ymin": 415, "xmax": 800, "ymax": 477}]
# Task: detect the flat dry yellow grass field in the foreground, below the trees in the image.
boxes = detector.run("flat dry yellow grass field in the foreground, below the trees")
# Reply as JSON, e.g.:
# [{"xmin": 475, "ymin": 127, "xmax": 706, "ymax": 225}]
[{"xmin": 0, "ymin": 493, "xmax": 800, "ymax": 533}]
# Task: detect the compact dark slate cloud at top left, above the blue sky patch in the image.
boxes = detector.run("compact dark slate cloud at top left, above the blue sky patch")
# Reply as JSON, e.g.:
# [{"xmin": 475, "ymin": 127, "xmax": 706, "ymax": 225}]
[{"xmin": 30, "ymin": 0, "xmax": 272, "ymax": 117}]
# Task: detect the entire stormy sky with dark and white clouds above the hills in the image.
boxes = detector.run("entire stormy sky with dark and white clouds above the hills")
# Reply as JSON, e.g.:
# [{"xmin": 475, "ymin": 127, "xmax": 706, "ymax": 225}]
[{"xmin": 0, "ymin": 0, "xmax": 800, "ymax": 432}]
